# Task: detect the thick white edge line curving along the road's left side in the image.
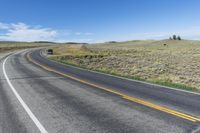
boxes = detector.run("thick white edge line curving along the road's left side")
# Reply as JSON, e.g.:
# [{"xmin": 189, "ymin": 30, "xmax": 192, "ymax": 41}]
[{"xmin": 3, "ymin": 53, "xmax": 48, "ymax": 133}]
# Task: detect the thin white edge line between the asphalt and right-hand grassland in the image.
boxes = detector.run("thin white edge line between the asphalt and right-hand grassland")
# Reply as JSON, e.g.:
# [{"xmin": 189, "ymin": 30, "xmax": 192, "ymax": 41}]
[{"xmin": 40, "ymin": 51, "xmax": 200, "ymax": 95}]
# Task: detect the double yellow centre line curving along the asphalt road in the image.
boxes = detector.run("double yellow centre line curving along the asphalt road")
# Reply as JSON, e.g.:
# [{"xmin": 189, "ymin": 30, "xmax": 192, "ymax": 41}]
[{"xmin": 27, "ymin": 53, "xmax": 200, "ymax": 122}]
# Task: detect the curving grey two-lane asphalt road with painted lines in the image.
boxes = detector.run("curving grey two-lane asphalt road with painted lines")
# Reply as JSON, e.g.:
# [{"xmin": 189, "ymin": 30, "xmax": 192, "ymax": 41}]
[{"xmin": 0, "ymin": 50, "xmax": 200, "ymax": 133}]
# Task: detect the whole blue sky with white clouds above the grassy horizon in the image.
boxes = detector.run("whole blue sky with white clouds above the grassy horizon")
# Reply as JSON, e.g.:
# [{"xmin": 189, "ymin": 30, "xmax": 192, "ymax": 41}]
[{"xmin": 0, "ymin": 0, "xmax": 200, "ymax": 42}]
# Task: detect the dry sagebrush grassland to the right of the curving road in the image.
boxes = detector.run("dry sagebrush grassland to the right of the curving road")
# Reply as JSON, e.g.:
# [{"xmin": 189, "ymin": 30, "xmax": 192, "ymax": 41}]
[{"xmin": 50, "ymin": 40, "xmax": 200, "ymax": 92}]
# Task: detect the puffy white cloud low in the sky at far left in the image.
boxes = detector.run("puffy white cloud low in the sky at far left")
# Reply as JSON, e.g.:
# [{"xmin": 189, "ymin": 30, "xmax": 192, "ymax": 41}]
[{"xmin": 0, "ymin": 23, "xmax": 58, "ymax": 41}]
